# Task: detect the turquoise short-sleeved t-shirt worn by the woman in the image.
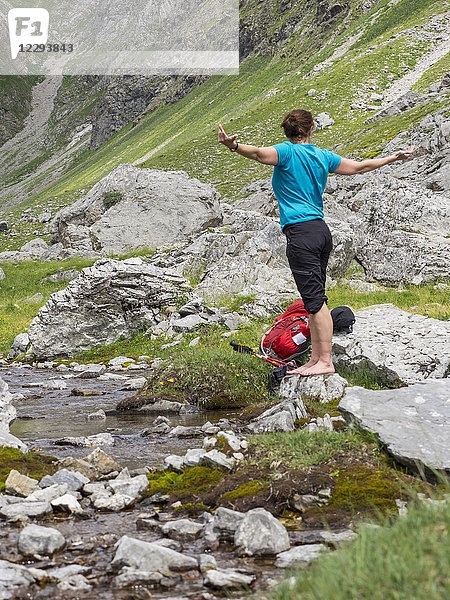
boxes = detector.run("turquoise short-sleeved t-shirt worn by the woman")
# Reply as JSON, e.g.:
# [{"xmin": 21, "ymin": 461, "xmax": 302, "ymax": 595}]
[{"xmin": 272, "ymin": 141, "xmax": 341, "ymax": 229}]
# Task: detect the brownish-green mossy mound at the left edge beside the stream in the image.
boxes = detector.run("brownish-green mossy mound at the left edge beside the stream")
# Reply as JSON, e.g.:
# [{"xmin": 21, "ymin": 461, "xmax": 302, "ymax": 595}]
[{"xmin": 0, "ymin": 448, "xmax": 58, "ymax": 492}]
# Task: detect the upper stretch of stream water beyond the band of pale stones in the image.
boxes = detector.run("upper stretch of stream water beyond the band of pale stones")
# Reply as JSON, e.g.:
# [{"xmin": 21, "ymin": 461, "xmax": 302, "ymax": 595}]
[{"xmin": 0, "ymin": 368, "xmax": 239, "ymax": 468}]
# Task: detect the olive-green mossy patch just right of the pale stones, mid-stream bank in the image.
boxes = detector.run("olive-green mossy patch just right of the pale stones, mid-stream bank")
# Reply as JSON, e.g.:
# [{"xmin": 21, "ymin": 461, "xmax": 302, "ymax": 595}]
[{"xmin": 147, "ymin": 467, "xmax": 225, "ymax": 504}]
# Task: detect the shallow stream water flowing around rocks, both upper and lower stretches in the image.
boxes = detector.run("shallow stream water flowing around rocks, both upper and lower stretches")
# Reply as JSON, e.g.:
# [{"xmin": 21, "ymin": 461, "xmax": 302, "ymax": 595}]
[{"xmin": 0, "ymin": 366, "xmax": 284, "ymax": 600}]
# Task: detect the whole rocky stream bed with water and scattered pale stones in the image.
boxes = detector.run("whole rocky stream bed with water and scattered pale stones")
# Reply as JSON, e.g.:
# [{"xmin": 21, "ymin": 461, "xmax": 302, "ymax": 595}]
[{"xmin": 0, "ymin": 365, "xmax": 356, "ymax": 600}]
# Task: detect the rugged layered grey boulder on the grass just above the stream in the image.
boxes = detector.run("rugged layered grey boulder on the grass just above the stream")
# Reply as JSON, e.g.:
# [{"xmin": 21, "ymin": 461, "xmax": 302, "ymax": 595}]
[{"xmin": 28, "ymin": 258, "xmax": 190, "ymax": 358}]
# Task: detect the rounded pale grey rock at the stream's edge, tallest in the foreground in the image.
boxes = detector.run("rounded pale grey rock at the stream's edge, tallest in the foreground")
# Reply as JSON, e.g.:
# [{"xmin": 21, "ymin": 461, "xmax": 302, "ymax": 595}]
[{"xmin": 234, "ymin": 508, "xmax": 290, "ymax": 556}]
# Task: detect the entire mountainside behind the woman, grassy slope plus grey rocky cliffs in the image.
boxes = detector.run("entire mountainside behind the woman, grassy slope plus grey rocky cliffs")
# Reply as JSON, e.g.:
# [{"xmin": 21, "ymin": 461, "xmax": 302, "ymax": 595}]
[{"xmin": 0, "ymin": 0, "xmax": 448, "ymax": 249}]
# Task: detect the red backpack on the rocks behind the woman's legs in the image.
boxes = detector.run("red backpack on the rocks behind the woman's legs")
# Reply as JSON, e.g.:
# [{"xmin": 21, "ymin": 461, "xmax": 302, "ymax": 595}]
[{"xmin": 260, "ymin": 300, "xmax": 310, "ymax": 360}]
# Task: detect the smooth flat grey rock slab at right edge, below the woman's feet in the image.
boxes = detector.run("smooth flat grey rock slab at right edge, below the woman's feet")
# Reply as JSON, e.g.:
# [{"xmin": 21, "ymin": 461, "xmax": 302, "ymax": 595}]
[{"xmin": 339, "ymin": 379, "xmax": 450, "ymax": 473}]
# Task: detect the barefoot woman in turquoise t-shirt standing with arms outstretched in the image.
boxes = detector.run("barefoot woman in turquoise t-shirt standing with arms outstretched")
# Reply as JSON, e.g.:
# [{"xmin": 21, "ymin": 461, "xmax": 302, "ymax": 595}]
[{"xmin": 219, "ymin": 109, "xmax": 414, "ymax": 375}]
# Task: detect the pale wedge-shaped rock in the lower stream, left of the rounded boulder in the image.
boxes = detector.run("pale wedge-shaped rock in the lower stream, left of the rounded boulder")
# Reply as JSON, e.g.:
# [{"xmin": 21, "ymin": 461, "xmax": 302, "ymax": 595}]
[{"xmin": 111, "ymin": 535, "xmax": 198, "ymax": 576}]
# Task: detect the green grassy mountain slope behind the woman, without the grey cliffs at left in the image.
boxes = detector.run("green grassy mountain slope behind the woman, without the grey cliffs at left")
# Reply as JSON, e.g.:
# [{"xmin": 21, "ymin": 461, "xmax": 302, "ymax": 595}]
[{"xmin": 0, "ymin": 0, "xmax": 450, "ymax": 249}]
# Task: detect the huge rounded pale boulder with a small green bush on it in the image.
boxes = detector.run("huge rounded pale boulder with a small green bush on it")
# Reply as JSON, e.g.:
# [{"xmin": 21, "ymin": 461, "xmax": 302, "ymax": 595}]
[{"xmin": 50, "ymin": 164, "xmax": 222, "ymax": 254}]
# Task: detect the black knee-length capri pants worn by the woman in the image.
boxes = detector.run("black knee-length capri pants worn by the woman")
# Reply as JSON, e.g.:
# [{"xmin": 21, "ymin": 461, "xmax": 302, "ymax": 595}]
[{"xmin": 283, "ymin": 219, "xmax": 333, "ymax": 314}]
